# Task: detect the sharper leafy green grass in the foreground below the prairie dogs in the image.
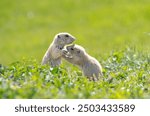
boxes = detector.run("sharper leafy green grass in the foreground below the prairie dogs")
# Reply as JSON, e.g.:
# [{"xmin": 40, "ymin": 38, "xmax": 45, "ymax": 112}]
[{"xmin": 0, "ymin": 49, "xmax": 150, "ymax": 98}]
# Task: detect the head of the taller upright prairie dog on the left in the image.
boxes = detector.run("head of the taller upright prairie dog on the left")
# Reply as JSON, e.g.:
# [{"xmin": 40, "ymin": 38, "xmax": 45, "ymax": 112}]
[{"xmin": 54, "ymin": 32, "xmax": 75, "ymax": 47}]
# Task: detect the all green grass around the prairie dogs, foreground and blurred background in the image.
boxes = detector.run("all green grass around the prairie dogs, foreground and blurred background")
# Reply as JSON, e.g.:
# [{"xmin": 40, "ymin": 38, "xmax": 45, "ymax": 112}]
[{"xmin": 0, "ymin": 0, "xmax": 150, "ymax": 98}]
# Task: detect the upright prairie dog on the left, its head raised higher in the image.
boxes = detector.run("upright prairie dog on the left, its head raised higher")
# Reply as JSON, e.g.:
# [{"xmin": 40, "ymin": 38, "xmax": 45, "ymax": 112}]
[{"xmin": 41, "ymin": 32, "xmax": 75, "ymax": 67}]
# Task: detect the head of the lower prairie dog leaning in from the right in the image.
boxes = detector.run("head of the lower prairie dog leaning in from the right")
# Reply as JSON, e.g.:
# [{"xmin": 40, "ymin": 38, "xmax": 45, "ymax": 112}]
[{"xmin": 66, "ymin": 44, "xmax": 86, "ymax": 64}]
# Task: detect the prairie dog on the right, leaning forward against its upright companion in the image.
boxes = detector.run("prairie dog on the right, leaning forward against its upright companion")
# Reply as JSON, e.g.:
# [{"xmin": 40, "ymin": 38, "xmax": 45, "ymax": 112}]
[{"xmin": 63, "ymin": 45, "xmax": 103, "ymax": 81}]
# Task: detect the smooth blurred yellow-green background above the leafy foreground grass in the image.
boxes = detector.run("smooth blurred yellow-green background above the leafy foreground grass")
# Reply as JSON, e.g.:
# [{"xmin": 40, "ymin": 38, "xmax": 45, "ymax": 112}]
[{"xmin": 0, "ymin": 0, "xmax": 150, "ymax": 65}]
